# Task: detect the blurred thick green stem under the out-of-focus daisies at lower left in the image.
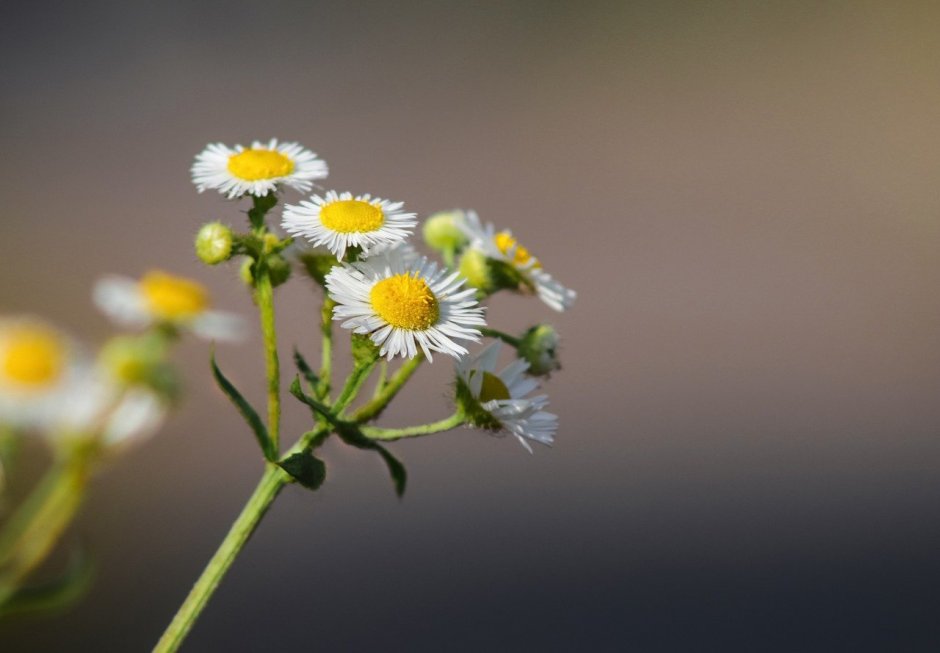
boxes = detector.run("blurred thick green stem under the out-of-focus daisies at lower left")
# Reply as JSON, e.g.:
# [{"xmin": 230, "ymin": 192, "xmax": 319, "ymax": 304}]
[{"xmin": 0, "ymin": 450, "xmax": 90, "ymax": 605}]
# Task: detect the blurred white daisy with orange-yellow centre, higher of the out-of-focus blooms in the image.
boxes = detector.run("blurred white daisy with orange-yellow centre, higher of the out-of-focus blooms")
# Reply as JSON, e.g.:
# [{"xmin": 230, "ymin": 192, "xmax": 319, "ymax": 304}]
[{"xmin": 94, "ymin": 270, "xmax": 243, "ymax": 340}]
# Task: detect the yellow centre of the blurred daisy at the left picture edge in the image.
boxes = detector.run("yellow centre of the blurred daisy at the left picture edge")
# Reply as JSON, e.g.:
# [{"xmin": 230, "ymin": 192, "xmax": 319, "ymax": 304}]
[{"xmin": 2, "ymin": 327, "xmax": 65, "ymax": 388}]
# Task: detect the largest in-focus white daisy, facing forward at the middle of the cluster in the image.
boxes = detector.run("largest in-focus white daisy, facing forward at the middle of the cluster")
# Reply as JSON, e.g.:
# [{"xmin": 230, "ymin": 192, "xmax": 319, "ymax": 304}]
[{"xmin": 326, "ymin": 248, "xmax": 486, "ymax": 360}]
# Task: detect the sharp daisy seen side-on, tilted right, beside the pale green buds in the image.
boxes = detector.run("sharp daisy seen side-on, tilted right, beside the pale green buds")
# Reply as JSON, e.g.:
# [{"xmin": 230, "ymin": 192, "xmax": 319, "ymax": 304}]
[{"xmin": 460, "ymin": 211, "xmax": 577, "ymax": 311}]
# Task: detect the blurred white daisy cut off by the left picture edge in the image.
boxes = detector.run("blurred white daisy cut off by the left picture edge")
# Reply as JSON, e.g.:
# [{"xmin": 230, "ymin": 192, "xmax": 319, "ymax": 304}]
[{"xmin": 0, "ymin": 317, "xmax": 90, "ymax": 428}]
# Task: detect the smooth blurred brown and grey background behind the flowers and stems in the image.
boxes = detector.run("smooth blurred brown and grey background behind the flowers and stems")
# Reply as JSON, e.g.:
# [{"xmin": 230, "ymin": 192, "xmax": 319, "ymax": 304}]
[{"xmin": 0, "ymin": 1, "xmax": 940, "ymax": 652}]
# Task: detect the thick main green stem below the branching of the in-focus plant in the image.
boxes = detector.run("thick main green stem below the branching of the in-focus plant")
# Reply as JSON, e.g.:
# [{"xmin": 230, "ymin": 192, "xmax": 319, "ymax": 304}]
[{"xmin": 153, "ymin": 427, "xmax": 327, "ymax": 653}]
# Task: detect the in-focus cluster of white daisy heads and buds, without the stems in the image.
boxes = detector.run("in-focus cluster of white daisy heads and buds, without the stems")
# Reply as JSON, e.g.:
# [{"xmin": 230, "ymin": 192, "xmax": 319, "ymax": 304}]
[{"xmin": 192, "ymin": 139, "xmax": 575, "ymax": 448}]
